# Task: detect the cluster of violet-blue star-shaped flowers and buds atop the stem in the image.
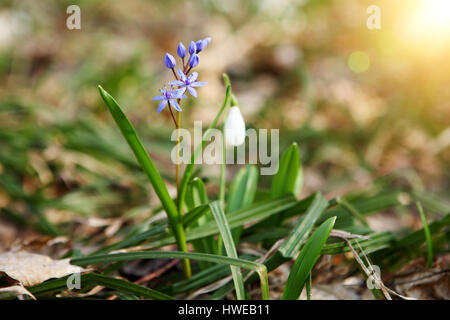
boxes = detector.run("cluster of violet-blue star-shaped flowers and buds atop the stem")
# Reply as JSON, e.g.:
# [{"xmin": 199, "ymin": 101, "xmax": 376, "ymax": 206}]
[{"xmin": 153, "ymin": 37, "xmax": 211, "ymax": 113}]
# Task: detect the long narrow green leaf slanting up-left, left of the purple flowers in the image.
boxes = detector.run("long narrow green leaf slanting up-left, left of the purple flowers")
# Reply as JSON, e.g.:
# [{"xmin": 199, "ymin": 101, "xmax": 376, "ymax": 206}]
[{"xmin": 98, "ymin": 86, "xmax": 190, "ymax": 277}]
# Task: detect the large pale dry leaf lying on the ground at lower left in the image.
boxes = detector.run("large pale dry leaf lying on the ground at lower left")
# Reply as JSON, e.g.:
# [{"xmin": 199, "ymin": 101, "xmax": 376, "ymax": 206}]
[{"xmin": 0, "ymin": 251, "xmax": 87, "ymax": 287}]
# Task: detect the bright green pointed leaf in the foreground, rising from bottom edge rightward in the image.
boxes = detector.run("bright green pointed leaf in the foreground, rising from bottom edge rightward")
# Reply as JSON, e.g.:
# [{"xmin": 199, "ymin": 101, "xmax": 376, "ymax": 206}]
[{"xmin": 282, "ymin": 217, "xmax": 336, "ymax": 300}]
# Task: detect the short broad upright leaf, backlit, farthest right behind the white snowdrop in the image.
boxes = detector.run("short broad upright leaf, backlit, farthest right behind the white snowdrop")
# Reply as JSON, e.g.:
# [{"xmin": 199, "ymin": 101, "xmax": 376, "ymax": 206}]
[{"xmin": 271, "ymin": 142, "xmax": 303, "ymax": 198}]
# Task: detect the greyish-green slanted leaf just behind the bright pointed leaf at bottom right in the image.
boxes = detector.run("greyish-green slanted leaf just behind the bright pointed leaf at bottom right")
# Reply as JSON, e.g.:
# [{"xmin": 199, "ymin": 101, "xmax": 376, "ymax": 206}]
[{"xmin": 279, "ymin": 192, "xmax": 328, "ymax": 258}]
